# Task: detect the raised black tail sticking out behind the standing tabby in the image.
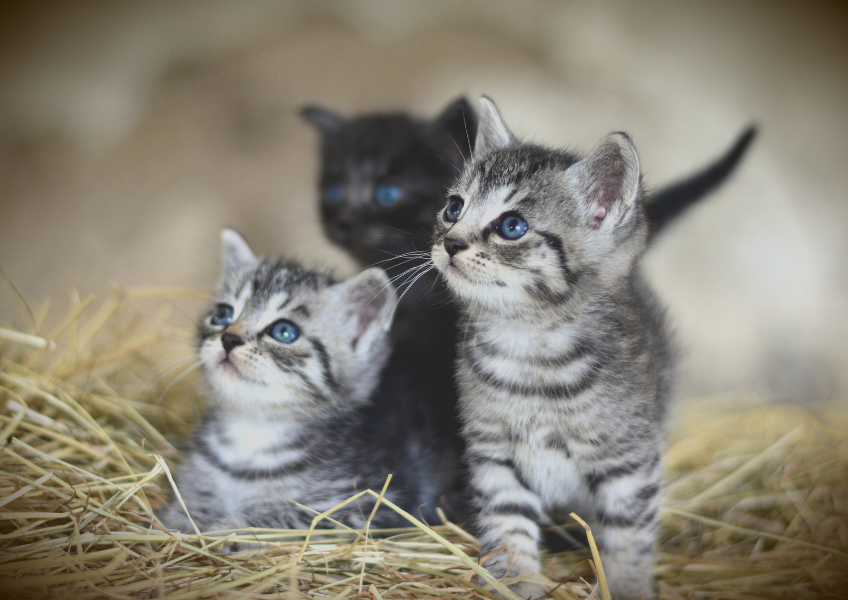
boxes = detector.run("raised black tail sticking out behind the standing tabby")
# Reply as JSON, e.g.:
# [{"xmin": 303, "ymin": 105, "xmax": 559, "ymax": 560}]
[{"xmin": 645, "ymin": 125, "xmax": 757, "ymax": 243}]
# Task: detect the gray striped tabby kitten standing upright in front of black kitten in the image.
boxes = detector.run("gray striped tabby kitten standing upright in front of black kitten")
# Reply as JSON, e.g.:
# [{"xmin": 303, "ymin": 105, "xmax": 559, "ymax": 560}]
[{"xmin": 432, "ymin": 98, "xmax": 673, "ymax": 599}]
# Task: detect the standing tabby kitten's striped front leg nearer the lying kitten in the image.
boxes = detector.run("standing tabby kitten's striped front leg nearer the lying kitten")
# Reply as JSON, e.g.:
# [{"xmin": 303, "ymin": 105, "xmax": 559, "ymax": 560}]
[{"xmin": 467, "ymin": 441, "xmax": 545, "ymax": 598}]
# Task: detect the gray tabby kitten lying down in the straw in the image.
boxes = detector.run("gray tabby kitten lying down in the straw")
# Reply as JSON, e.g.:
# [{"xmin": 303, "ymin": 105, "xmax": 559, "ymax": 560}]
[{"xmin": 163, "ymin": 230, "xmax": 457, "ymax": 531}]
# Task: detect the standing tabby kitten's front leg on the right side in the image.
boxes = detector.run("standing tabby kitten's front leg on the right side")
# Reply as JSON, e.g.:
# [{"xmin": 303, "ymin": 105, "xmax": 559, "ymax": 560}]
[{"xmin": 595, "ymin": 466, "xmax": 660, "ymax": 600}]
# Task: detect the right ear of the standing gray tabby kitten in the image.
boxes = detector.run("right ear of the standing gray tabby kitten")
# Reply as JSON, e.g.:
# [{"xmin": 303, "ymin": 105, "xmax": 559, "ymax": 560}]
[{"xmin": 566, "ymin": 132, "xmax": 641, "ymax": 229}]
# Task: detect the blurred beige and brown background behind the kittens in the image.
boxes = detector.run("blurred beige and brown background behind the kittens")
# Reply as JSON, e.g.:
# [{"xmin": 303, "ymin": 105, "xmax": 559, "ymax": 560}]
[{"xmin": 0, "ymin": 0, "xmax": 848, "ymax": 403}]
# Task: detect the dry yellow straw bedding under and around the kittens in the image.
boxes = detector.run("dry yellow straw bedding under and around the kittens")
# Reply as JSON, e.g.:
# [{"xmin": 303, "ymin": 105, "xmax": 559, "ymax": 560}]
[{"xmin": 0, "ymin": 290, "xmax": 848, "ymax": 600}]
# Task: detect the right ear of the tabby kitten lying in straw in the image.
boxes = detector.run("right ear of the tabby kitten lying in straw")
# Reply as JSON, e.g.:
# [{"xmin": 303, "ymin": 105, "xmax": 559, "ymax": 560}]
[{"xmin": 338, "ymin": 267, "xmax": 397, "ymax": 355}]
